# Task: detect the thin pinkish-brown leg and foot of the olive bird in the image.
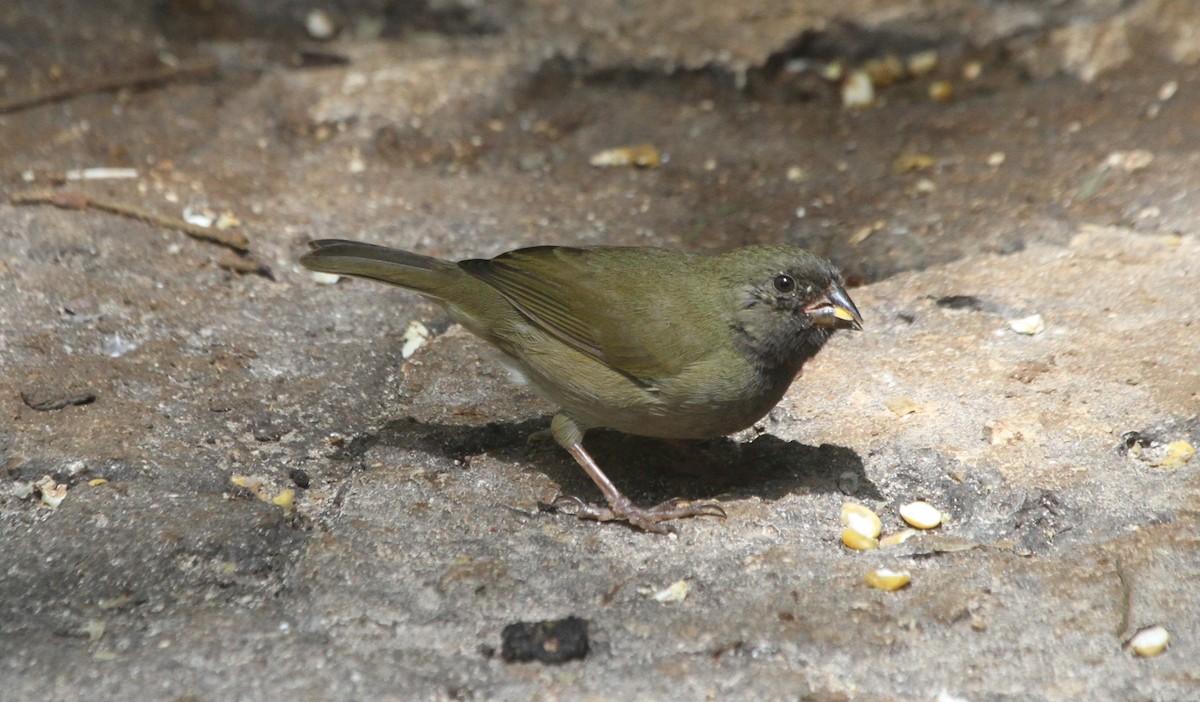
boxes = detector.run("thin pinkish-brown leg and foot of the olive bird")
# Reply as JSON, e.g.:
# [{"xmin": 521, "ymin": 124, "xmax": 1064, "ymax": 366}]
[{"xmin": 550, "ymin": 413, "xmax": 725, "ymax": 534}]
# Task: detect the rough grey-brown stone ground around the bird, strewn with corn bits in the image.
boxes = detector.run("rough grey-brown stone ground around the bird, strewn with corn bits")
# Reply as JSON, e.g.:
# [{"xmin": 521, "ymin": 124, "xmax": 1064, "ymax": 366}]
[{"xmin": 0, "ymin": 0, "xmax": 1200, "ymax": 702}]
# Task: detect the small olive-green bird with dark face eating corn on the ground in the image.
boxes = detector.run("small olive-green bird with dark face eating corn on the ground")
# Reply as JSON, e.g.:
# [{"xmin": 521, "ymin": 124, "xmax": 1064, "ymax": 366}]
[{"xmin": 300, "ymin": 239, "xmax": 863, "ymax": 533}]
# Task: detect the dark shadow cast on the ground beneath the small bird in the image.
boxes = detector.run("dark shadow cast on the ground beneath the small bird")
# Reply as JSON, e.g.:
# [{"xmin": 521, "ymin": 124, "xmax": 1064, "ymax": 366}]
[{"xmin": 341, "ymin": 418, "xmax": 882, "ymax": 505}]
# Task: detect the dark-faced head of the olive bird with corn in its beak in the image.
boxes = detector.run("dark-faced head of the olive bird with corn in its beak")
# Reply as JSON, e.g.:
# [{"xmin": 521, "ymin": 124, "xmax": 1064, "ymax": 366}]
[{"xmin": 736, "ymin": 251, "xmax": 863, "ymax": 370}]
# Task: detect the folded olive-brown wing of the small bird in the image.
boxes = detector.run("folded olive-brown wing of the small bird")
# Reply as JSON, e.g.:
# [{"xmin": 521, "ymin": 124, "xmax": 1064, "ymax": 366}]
[{"xmin": 458, "ymin": 246, "xmax": 703, "ymax": 380}]
